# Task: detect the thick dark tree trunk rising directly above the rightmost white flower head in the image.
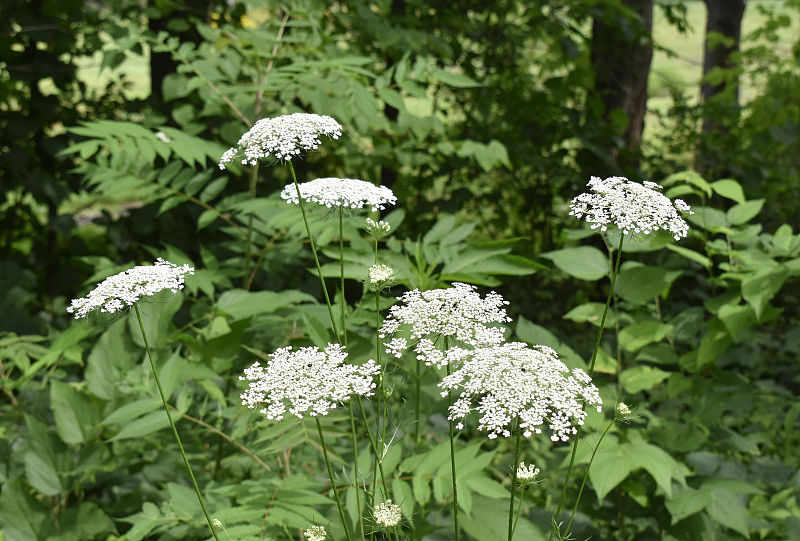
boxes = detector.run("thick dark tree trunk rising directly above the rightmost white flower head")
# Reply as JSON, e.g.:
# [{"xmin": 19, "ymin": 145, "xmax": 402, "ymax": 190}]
[{"xmin": 591, "ymin": 0, "xmax": 653, "ymax": 168}]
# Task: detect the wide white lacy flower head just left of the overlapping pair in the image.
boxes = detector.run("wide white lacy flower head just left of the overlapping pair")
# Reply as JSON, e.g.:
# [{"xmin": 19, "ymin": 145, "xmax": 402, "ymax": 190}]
[{"xmin": 239, "ymin": 344, "xmax": 380, "ymax": 421}]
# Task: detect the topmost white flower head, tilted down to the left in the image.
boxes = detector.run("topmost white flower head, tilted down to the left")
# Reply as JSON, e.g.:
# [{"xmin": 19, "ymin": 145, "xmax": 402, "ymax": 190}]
[{"xmin": 219, "ymin": 113, "xmax": 342, "ymax": 169}]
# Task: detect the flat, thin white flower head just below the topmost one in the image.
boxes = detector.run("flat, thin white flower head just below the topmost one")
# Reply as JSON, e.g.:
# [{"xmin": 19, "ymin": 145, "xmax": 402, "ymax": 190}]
[{"xmin": 281, "ymin": 178, "xmax": 397, "ymax": 210}]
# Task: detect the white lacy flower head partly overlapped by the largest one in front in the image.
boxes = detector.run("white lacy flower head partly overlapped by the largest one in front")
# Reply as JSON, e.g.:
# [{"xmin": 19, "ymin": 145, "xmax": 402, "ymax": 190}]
[{"xmin": 380, "ymin": 282, "xmax": 511, "ymax": 368}]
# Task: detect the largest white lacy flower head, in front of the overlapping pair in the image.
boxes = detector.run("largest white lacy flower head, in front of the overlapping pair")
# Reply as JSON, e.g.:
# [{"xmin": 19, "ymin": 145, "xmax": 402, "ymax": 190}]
[{"xmin": 439, "ymin": 342, "xmax": 602, "ymax": 441}]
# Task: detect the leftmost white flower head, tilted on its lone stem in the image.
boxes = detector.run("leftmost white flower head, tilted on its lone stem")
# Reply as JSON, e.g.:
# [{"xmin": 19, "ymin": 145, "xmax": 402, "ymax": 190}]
[{"xmin": 67, "ymin": 257, "xmax": 194, "ymax": 319}]
